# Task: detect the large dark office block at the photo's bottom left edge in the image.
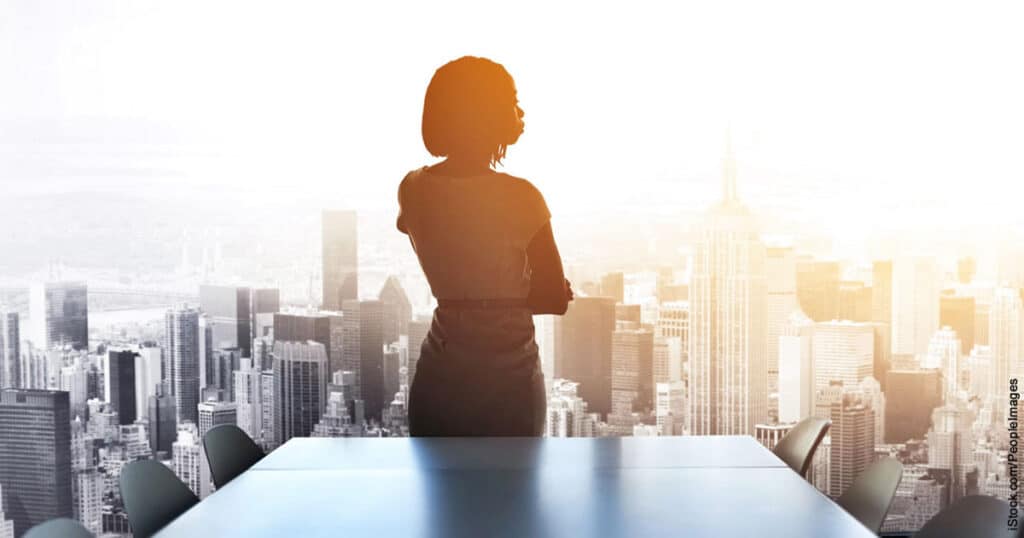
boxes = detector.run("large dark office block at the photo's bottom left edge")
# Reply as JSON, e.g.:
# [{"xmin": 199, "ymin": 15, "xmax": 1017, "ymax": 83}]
[{"xmin": 0, "ymin": 388, "xmax": 73, "ymax": 536}]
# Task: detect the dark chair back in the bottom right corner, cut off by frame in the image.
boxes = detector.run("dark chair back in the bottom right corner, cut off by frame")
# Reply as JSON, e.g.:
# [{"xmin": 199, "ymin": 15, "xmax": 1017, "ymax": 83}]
[{"xmin": 913, "ymin": 495, "xmax": 1018, "ymax": 538}]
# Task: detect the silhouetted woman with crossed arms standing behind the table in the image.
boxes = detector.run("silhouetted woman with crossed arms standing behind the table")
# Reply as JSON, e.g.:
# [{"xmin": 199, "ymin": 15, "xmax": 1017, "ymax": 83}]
[{"xmin": 398, "ymin": 56, "xmax": 572, "ymax": 437}]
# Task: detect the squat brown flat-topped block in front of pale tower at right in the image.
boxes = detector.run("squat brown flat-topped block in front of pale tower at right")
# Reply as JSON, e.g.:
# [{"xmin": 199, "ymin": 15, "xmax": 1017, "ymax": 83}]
[{"xmin": 886, "ymin": 370, "xmax": 942, "ymax": 443}]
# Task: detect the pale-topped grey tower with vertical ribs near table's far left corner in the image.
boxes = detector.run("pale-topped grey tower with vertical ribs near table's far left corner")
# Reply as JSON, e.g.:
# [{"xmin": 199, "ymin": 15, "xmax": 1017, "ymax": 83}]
[{"xmin": 273, "ymin": 340, "xmax": 327, "ymax": 446}]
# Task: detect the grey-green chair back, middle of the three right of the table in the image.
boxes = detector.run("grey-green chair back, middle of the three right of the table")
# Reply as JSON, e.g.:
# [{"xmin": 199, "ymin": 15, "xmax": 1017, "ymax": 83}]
[{"xmin": 836, "ymin": 458, "xmax": 903, "ymax": 534}]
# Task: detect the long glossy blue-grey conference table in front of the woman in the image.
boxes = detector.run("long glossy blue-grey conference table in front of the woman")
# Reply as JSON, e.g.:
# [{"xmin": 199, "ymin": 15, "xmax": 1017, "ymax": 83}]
[{"xmin": 158, "ymin": 436, "xmax": 873, "ymax": 538}]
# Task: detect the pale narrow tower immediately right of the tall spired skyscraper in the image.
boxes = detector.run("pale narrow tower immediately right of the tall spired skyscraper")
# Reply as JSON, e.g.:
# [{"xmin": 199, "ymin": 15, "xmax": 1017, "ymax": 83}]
[{"xmin": 765, "ymin": 246, "xmax": 800, "ymax": 407}]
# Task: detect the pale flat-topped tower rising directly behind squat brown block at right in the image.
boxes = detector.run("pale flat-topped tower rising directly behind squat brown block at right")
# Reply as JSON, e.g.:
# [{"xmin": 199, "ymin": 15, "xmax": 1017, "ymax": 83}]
[{"xmin": 892, "ymin": 256, "xmax": 941, "ymax": 356}]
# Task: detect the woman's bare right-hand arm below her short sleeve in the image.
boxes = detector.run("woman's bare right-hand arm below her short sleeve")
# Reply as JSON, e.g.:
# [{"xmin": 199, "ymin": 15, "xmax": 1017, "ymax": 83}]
[{"xmin": 526, "ymin": 221, "xmax": 572, "ymax": 316}]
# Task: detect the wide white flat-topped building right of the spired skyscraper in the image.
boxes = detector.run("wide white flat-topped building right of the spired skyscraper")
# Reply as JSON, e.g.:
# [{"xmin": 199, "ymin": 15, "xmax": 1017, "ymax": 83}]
[{"xmin": 811, "ymin": 321, "xmax": 874, "ymax": 392}]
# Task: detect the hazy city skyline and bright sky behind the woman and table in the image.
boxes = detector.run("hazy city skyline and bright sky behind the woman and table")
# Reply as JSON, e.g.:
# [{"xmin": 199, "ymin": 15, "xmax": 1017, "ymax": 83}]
[{"xmin": 0, "ymin": 1, "xmax": 1024, "ymax": 538}]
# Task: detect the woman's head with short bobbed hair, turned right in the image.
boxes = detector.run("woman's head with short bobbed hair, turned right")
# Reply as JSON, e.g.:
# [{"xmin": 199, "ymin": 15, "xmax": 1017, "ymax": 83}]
[{"xmin": 422, "ymin": 56, "xmax": 519, "ymax": 164}]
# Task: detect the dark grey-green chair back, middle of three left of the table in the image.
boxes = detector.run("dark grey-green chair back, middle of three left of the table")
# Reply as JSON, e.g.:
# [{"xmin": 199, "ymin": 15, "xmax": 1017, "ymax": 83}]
[{"xmin": 121, "ymin": 459, "xmax": 199, "ymax": 538}]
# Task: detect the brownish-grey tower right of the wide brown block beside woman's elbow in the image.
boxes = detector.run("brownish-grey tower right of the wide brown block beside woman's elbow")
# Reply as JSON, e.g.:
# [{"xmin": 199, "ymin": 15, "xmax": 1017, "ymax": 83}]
[{"xmin": 608, "ymin": 322, "xmax": 654, "ymax": 427}]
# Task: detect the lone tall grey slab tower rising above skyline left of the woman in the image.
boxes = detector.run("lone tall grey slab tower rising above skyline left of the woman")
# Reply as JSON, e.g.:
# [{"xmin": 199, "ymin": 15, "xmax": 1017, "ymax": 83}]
[{"xmin": 321, "ymin": 210, "xmax": 359, "ymax": 311}]
